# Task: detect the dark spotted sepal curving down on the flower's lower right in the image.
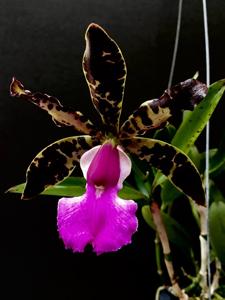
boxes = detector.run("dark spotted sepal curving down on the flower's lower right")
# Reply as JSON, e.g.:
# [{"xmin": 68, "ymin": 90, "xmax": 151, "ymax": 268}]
[{"xmin": 122, "ymin": 138, "xmax": 205, "ymax": 205}]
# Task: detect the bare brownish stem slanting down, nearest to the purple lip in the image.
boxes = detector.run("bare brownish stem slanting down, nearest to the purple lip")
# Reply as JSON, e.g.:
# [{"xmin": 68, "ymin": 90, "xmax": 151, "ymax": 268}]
[{"xmin": 150, "ymin": 201, "xmax": 188, "ymax": 300}]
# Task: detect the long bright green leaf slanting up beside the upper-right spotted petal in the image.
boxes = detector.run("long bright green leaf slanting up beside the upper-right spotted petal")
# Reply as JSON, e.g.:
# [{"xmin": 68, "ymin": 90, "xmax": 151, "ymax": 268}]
[{"xmin": 172, "ymin": 79, "xmax": 225, "ymax": 153}]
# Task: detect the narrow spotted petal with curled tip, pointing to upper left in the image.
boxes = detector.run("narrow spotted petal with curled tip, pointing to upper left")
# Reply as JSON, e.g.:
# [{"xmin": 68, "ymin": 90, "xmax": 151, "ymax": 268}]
[{"xmin": 10, "ymin": 78, "xmax": 96, "ymax": 135}]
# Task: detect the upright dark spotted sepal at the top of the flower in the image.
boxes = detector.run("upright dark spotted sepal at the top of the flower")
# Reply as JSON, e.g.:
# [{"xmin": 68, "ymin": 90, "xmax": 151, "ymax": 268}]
[{"xmin": 83, "ymin": 24, "xmax": 126, "ymax": 134}]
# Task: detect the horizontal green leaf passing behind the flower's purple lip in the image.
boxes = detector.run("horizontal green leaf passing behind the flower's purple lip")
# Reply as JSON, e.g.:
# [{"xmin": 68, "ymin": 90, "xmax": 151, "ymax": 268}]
[{"xmin": 7, "ymin": 177, "xmax": 145, "ymax": 200}]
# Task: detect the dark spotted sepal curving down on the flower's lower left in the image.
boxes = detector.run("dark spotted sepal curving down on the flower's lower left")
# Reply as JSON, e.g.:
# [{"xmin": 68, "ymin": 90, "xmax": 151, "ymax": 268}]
[{"xmin": 22, "ymin": 135, "xmax": 98, "ymax": 199}]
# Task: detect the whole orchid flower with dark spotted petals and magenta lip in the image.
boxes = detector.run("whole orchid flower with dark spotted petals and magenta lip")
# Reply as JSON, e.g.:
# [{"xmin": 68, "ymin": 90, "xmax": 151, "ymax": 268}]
[{"xmin": 11, "ymin": 24, "xmax": 207, "ymax": 254}]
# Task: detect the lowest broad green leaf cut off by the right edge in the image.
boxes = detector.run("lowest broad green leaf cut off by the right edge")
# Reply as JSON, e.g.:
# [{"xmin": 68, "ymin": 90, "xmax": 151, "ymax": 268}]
[{"xmin": 209, "ymin": 201, "xmax": 225, "ymax": 264}]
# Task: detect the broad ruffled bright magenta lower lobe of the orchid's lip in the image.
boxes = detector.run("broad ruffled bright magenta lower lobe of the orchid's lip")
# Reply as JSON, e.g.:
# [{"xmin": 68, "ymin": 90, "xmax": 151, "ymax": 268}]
[{"xmin": 57, "ymin": 186, "xmax": 138, "ymax": 254}]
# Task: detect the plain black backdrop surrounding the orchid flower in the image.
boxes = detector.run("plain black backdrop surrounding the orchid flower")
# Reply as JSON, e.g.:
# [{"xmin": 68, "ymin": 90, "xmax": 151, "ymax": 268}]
[{"xmin": 0, "ymin": 0, "xmax": 225, "ymax": 300}]
